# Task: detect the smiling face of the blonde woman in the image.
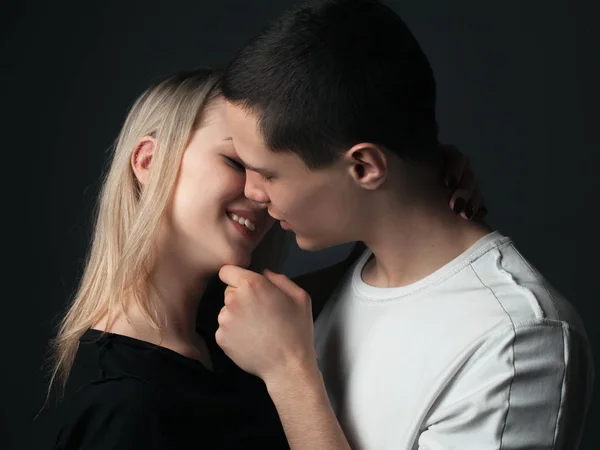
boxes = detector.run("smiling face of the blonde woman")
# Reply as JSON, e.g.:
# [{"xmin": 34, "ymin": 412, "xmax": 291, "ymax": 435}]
[{"xmin": 163, "ymin": 98, "xmax": 273, "ymax": 271}]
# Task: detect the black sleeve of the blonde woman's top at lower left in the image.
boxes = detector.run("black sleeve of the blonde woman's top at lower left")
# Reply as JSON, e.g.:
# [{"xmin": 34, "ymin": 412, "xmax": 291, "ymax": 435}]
[{"xmin": 54, "ymin": 378, "xmax": 169, "ymax": 450}]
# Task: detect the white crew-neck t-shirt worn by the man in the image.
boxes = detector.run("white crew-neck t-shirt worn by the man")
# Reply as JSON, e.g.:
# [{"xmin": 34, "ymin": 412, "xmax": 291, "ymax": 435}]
[{"xmin": 315, "ymin": 232, "xmax": 593, "ymax": 450}]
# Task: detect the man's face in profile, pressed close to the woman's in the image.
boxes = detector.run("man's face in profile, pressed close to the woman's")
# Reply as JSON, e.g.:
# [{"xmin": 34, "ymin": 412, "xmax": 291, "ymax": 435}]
[{"xmin": 227, "ymin": 102, "xmax": 360, "ymax": 250}]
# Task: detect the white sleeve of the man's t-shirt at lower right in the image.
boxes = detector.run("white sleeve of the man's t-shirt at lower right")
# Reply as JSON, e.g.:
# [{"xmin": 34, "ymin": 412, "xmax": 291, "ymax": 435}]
[{"xmin": 418, "ymin": 322, "xmax": 593, "ymax": 450}]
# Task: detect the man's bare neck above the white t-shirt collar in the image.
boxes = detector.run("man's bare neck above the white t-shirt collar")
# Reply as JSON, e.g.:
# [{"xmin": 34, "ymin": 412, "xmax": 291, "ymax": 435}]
[{"xmin": 362, "ymin": 190, "xmax": 490, "ymax": 287}]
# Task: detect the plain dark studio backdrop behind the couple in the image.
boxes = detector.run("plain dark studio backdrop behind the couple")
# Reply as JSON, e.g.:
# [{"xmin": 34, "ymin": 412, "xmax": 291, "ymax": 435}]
[{"xmin": 0, "ymin": 0, "xmax": 600, "ymax": 450}]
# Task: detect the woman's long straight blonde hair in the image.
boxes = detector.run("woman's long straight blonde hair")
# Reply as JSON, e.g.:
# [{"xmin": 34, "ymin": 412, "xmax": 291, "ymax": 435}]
[{"xmin": 48, "ymin": 69, "xmax": 286, "ymax": 394}]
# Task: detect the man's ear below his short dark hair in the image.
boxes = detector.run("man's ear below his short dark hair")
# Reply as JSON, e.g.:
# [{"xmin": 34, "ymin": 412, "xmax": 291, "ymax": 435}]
[{"xmin": 345, "ymin": 143, "xmax": 388, "ymax": 190}]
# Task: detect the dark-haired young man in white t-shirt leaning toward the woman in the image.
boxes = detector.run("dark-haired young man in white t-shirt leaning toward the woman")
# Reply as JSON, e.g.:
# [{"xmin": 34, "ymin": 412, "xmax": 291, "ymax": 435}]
[{"xmin": 216, "ymin": 0, "xmax": 593, "ymax": 450}]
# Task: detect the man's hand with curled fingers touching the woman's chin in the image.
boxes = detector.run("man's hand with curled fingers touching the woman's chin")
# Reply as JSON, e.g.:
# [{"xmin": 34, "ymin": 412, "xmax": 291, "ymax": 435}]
[{"xmin": 215, "ymin": 265, "xmax": 316, "ymax": 385}]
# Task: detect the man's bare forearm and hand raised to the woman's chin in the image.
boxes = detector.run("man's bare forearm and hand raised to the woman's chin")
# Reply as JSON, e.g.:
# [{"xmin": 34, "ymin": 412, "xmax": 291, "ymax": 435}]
[{"xmin": 215, "ymin": 266, "xmax": 350, "ymax": 450}]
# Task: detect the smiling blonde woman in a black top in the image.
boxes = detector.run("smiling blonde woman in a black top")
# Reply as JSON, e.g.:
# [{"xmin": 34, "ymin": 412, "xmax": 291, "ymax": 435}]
[{"xmin": 44, "ymin": 70, "xmax": 480, "ymax": 450}]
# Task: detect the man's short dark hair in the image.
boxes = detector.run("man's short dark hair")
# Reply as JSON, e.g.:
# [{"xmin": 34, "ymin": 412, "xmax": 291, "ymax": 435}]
[{"xmin": 223, "ymin": 0, "xmax": 439, "ymax": 168}]
